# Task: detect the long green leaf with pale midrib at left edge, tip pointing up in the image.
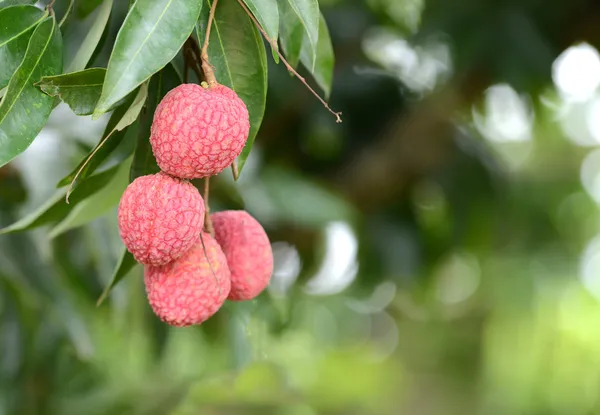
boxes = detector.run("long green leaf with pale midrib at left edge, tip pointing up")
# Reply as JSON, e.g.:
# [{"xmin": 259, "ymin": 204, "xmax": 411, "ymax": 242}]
[{"xmin": 0, "ymin": 17, "xmax": 62, "ymax": 166}]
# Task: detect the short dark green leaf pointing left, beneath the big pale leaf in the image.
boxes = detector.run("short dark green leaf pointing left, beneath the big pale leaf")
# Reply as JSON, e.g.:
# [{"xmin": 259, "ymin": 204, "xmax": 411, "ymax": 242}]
[{"xmin": 36, "ymin": 68, "xmax": 106, "ymax": 115}]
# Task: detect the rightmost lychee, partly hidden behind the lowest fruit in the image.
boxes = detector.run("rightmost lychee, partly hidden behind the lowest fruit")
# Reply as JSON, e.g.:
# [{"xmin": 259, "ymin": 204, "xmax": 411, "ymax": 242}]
[{"xmin": 211, "ymin": 210, "xmax": 273, "ymax": 301}]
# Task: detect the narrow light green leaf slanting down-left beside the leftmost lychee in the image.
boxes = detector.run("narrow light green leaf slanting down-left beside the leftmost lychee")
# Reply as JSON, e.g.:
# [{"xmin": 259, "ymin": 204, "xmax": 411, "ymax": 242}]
[{"xmin": 49, "ymin": 157, "xmax": 131, "ymax": 238}]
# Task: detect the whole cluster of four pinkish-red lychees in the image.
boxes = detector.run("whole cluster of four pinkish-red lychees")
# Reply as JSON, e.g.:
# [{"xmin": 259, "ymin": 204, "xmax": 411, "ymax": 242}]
[{"xmin": 118, "ymin": 84, "xmax": 273, "ymax": 327}]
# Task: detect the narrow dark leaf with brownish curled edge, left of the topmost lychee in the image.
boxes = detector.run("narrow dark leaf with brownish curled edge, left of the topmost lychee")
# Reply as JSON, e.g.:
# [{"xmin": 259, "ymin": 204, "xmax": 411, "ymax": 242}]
[{"xmin": 58, "ymin": 83, "xmax": 148, "ymax": 193}]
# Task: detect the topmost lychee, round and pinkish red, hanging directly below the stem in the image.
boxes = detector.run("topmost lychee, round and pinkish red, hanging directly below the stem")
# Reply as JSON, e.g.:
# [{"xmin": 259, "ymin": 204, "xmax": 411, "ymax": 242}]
[{"xmin": 150, "ymin": 84, "xmax": 250, "ymax": 179}]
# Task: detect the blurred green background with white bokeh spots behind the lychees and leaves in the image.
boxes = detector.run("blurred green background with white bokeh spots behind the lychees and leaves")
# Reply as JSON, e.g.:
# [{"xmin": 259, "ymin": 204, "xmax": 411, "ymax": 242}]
[{"xmin": 0, "ymin": 0, "xmax": 600, "ymax": 415}]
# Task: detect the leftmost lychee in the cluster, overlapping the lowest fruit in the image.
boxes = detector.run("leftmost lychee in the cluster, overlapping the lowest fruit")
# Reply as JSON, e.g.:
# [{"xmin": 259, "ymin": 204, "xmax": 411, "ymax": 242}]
[{"xmin": 118, "ymin": 173, "xmax": 205, "ymax": 265}]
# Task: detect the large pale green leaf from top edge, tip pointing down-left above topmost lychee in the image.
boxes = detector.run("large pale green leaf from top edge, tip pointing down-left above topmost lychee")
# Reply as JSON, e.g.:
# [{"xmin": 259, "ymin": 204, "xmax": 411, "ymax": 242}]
[{"xmin": 94, "ymin": 0, "xmax": 202, "ymax": 118}]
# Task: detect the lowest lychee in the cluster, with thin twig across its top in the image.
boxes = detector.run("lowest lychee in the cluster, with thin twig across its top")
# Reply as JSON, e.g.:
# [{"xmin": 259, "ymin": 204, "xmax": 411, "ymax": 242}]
[{"xmin": 144, "ymin": 233, "xmax": 231, "ymax": 327}]
